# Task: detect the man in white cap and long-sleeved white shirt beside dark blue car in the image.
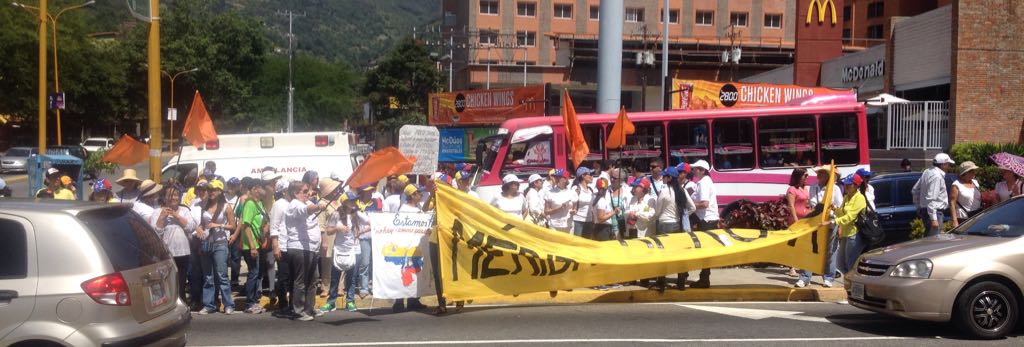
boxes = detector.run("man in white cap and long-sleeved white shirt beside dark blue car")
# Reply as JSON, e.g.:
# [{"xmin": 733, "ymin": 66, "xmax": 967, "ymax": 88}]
[{"xmin": 910, "ymin": 153, "xmax": 956, "ymax": 237}]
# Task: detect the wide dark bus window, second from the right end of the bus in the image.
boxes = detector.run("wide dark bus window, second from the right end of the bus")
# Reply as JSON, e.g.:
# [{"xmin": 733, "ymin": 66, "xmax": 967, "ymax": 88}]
[{"xmin": 758, "ymin": 116, "xmax": 818, "ymax": 168}]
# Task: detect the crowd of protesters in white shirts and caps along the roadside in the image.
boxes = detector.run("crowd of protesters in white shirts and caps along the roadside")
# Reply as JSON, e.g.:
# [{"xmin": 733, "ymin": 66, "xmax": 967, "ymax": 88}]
[{"xmin": 18, "ymin": 149, "xmax": 1024, "ymax": 320}]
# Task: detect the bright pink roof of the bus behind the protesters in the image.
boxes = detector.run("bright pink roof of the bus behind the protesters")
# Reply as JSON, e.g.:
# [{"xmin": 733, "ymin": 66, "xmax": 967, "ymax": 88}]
[{"xmin": 502, "ymin": 101, "xmax": 864, "ymax": 132}]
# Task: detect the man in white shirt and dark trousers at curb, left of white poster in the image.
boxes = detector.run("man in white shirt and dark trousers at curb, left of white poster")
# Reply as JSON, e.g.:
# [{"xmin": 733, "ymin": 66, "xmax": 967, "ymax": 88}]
[{"xmin": 285, "ymin": 181, "xmax": 323, "ymax": 321}]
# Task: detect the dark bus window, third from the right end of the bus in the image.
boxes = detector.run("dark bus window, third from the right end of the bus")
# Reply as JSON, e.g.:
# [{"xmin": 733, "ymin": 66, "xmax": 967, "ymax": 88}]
[{"xmin": 712, "ymin": 119, "xmax": 755, "ymax": 171}]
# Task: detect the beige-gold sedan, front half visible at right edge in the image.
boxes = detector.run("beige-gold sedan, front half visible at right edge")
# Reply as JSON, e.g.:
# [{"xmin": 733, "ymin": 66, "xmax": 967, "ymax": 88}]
[{"xmin": 844, "ymin": 198, "xmax": 1024, "ymax": 339}]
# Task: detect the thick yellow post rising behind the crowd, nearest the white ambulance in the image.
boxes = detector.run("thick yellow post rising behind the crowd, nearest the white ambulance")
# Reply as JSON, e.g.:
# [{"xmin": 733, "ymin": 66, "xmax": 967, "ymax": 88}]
[{"xmin": 146, "ymin": 0, "xmax": 164, "ymax": 182}]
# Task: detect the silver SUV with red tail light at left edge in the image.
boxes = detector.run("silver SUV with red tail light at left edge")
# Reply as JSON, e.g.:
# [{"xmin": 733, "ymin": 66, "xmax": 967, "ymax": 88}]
[{"xmin": 0, "ymin": 199, "xmax": 191, "ymax": 346}]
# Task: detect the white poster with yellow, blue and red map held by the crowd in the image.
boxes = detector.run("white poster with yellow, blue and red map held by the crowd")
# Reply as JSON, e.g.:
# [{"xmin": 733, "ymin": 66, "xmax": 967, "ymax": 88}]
[{"xmin": 370, "ymin": 213, "xmax": 436, "ymax": 299}]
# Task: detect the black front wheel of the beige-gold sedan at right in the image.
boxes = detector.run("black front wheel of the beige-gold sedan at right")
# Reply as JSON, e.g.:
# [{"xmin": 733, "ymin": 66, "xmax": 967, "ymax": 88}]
[{"xmin": 953, "ymin": 281, "xmax": 1020, "ymax": 339}]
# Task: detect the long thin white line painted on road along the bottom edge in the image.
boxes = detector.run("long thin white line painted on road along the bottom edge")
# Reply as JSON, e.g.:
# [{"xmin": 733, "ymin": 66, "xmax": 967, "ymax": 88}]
[{"xmin": 193, "ymin": 336, "xmax": 912, "ymax": 347}]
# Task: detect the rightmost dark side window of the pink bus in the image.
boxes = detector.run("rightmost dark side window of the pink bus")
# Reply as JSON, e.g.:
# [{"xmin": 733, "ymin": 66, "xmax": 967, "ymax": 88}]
[{"xmin": 819, "ymin": 114, "xmax": 860, "ymax": 165}]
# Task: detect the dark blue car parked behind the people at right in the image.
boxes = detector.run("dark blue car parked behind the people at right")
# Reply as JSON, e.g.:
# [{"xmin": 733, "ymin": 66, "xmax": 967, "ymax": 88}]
[{"xmin": 870, "ymin": 172, "xmax": 956, "ymax": 247}]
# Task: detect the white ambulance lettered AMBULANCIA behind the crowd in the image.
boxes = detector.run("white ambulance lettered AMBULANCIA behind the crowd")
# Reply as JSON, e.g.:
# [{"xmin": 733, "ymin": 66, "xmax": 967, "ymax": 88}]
[{"xmin": 161, "ymin": 132, "xmax": 369, "ymax": 182}]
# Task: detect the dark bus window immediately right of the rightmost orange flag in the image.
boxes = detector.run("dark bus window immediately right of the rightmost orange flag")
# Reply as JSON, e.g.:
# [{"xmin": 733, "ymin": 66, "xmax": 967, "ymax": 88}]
[{"xmin": 608, "ymin": 122, "xmax": 665, "ymax": 172}]
